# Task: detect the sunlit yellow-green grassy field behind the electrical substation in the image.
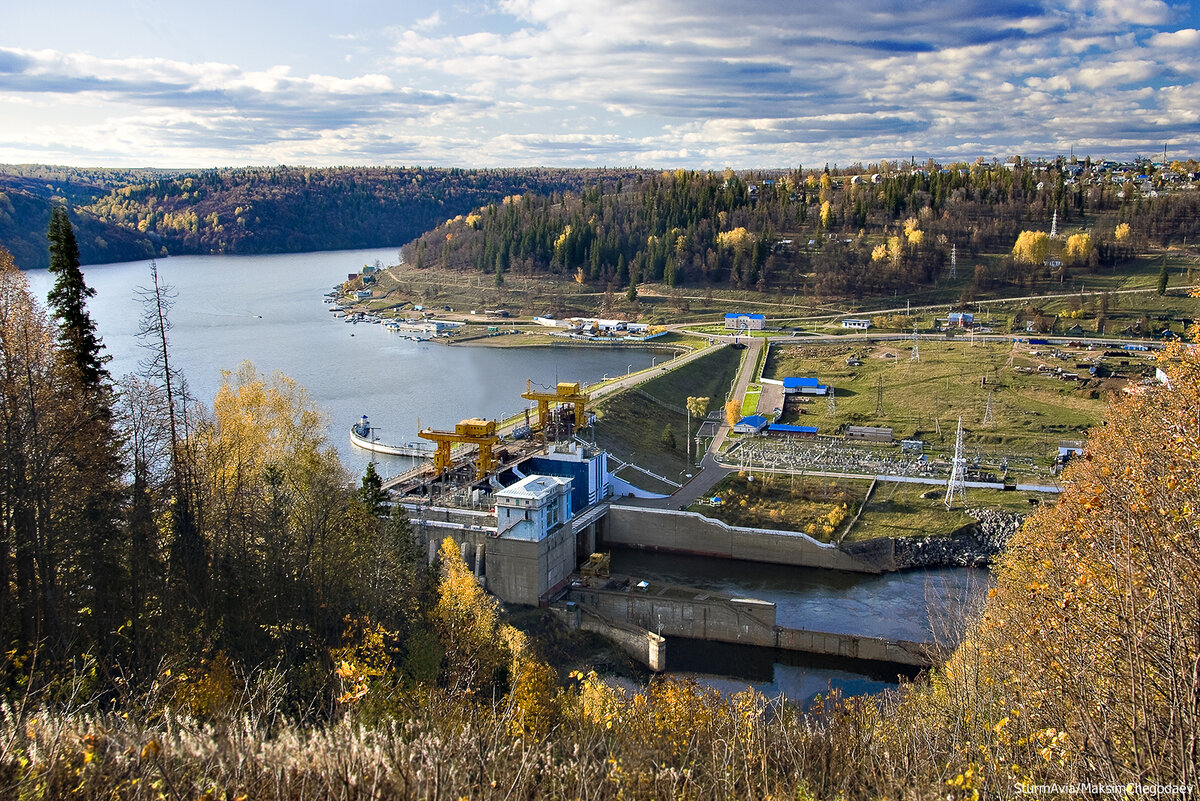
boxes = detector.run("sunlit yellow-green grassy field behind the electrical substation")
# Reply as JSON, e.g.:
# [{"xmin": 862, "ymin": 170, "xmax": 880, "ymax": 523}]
[{"xmin": 764, "ymin": 338, "xmax": 1123, "ymax": 459}]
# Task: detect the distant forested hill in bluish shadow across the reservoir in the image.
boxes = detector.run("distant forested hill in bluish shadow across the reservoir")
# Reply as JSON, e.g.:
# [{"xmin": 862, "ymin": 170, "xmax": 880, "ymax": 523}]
[{"xmin": 0, "ymin": 165, "xmax": 637, "ymax": 269}]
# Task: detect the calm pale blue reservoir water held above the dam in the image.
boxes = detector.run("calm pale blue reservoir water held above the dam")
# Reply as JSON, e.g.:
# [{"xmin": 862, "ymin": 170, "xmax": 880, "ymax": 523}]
[{"xmin": 29, "ymin": 248, "xmax": 661, "ymax": 475}]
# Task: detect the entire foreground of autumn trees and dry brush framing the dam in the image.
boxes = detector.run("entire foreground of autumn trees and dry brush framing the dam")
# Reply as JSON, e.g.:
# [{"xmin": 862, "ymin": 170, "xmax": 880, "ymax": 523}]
[{"xmin": 0, "ymin": 205, "xmax": 1200, "ymax": 800}]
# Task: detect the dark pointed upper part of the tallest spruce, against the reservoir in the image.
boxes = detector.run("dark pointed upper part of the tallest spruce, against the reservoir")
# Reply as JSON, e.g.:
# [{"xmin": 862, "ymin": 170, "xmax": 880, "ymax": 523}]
[{"xmin": 46, "ymin": 206, "xmax": 110, "ymax": 390}]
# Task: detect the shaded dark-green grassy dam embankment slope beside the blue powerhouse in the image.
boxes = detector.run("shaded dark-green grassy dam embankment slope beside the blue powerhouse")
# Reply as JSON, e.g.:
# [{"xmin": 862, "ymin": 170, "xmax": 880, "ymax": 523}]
[{"xmin": 595, "ymin": 348, "xmax": 745, "ymax": 492}]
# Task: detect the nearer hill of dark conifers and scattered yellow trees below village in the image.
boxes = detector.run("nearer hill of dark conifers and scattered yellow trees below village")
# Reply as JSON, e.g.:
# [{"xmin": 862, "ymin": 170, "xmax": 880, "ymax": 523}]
[{"xmin": 404, "ymin": 163, "xmax": 1200, "ymax": 295}]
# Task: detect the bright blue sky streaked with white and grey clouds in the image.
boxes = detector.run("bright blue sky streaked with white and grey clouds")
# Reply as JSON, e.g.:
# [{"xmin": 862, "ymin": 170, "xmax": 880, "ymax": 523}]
[{"xmin": 0, "ymin": 0, "xmax": 1200, "ymax": 169}]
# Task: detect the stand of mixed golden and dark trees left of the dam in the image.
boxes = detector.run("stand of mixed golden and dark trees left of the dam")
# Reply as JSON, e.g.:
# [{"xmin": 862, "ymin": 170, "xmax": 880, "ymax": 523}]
[{"xmin": 0, "ymin": 215, "xmax": 442, "ymax": 719}]
